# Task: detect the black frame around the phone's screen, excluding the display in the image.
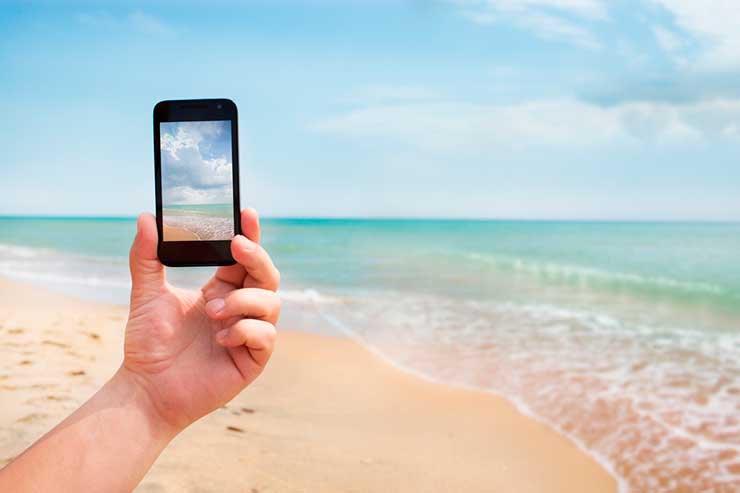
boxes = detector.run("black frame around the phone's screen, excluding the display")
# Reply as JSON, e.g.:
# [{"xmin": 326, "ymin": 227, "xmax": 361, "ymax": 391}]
[{"xmin": 153, "ymin": 99, "xmax": 241, "ymax": 267}]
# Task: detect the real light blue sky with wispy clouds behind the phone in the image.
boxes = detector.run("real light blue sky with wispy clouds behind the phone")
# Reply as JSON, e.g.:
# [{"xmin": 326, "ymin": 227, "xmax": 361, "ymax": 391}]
[{"xmin": 0, "ymin": 0, "xmax": 740, "ymax": 220}]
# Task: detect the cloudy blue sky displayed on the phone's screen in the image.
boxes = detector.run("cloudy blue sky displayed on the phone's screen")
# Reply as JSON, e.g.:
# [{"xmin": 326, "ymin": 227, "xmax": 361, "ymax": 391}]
[{"xmin": 160, "ymin": 120, "xmax": 234, "ymax": 207}]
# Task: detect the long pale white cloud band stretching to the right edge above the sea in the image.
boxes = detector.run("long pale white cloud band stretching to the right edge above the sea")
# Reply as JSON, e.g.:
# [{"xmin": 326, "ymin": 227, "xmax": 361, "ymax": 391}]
[{"xmin": 314, "ymin": 99, "xmax": 740, "ymax": 152}]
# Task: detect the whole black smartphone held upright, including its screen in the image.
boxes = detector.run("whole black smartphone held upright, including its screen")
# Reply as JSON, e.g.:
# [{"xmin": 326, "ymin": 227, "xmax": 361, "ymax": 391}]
[{"xmin": 154, "ymin": 99, "xmax": 241, "ymax": 267}]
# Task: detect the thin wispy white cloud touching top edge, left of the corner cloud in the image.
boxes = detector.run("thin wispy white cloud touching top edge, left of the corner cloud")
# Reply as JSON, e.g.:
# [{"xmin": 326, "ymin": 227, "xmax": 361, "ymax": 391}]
[{"xmin": 456, "ymin": 0, "xmax": 608, "ymax": 50}]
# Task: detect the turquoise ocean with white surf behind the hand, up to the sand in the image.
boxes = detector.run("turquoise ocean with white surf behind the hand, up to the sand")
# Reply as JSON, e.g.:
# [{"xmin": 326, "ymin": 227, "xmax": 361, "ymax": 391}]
[{"xmin": 0, "ymin": 218, "xmax": 740, "ymax": 492}]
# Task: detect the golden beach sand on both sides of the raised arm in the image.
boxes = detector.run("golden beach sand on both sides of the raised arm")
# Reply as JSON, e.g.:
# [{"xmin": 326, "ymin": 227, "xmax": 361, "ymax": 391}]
[{"xmin": 0, "ymin": 280, "xmax": 616, "ymax": 493}]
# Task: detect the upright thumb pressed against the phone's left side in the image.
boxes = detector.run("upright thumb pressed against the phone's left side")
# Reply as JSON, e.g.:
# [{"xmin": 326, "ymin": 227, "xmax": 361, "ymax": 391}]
[{"xmin": 129, "ymin": 212, "xmax": 165, "ymax": 295}]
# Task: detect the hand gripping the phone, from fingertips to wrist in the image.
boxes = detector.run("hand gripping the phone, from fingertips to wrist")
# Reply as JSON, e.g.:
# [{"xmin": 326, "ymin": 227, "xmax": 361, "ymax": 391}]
[{"xmin": 116, "ymin": 209, "xmax": 280, "ymax": 433}]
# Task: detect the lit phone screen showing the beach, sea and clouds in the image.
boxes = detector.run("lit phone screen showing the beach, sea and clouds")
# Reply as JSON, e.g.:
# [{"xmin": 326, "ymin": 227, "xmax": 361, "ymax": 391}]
[{"xmin": 159, "ymin": 120, "xmax": 234, "ymax": 241}]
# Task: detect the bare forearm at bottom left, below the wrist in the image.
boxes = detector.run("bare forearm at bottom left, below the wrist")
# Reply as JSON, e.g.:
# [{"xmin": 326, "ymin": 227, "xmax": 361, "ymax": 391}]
[{"xmin": 0, "ymin": 369, "xmax": 177, "ymax": 492}]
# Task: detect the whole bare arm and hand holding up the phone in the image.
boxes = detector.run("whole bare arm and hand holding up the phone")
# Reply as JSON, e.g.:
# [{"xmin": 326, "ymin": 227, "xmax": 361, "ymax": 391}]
[{"xmin": 0, "ymin": 209, "xmax": 280, "ymax": 493}]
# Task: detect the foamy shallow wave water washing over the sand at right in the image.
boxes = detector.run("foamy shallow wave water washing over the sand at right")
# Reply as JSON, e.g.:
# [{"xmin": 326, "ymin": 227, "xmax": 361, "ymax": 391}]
[{"xmin": 286, "ymin": 292, "xmax": 740, "ymax": 492}]
